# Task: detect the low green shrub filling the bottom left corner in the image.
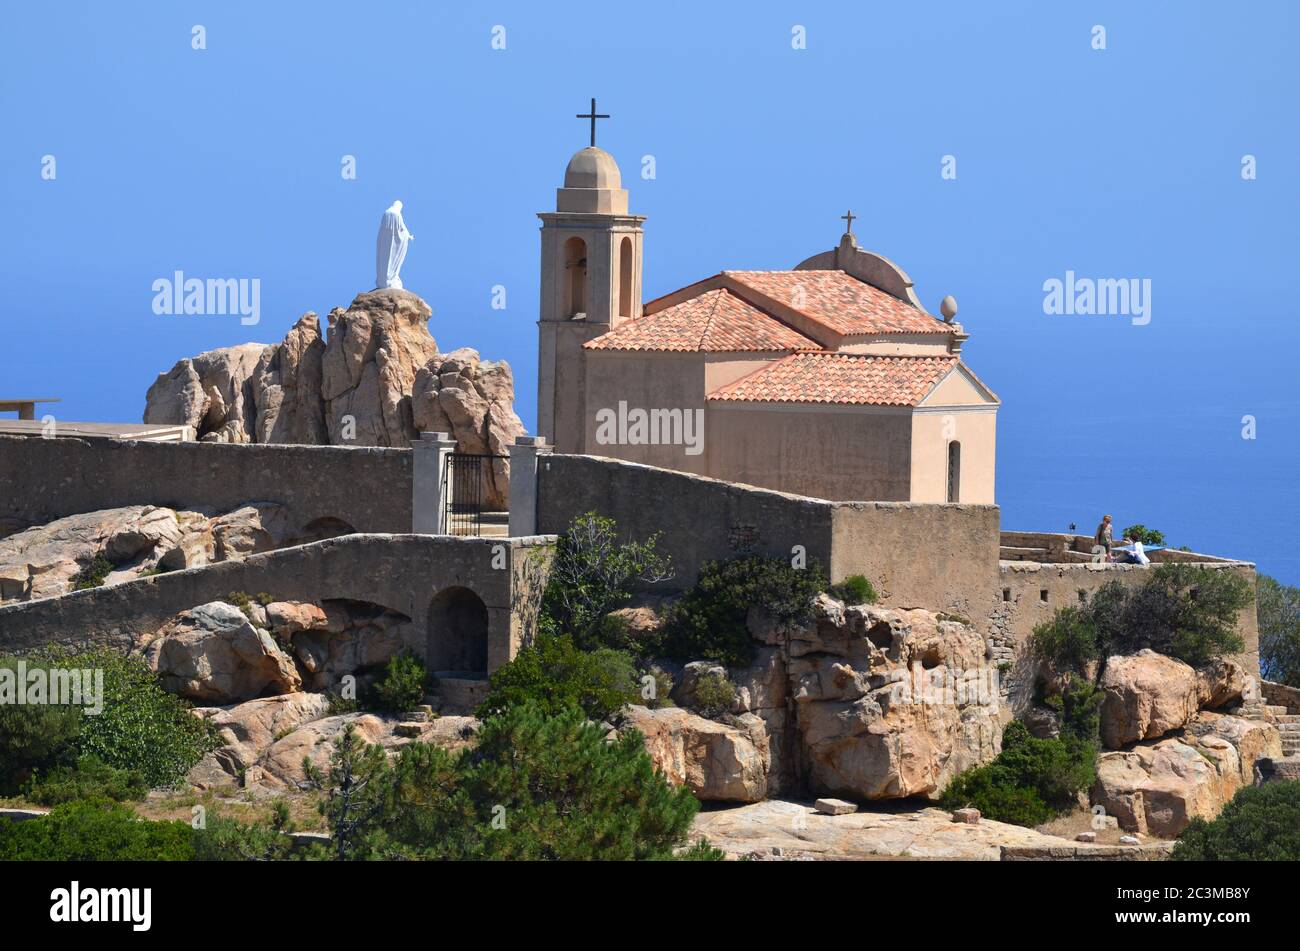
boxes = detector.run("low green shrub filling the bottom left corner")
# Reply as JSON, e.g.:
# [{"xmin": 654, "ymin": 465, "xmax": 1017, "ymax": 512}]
[{"xmin": 0, "ymin": 799, "xmax": 194, "ymax": 861}]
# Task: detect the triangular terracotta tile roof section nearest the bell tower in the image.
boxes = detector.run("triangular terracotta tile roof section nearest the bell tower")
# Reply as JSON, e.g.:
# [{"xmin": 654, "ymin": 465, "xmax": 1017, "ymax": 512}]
[{"xmin": 584, "ymin": 288, "xmax": 818, "ymax": 352}]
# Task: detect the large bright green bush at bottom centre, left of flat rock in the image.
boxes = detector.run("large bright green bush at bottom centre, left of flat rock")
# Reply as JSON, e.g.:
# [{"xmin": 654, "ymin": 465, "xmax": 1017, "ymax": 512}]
[{"xmin": 363, "ymin": 707, "xmax": 719, "ymax": 860}]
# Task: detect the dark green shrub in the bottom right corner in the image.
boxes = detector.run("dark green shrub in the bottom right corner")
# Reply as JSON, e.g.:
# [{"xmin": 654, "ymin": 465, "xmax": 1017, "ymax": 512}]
[{"xmin": 1171, "ymin": 781, "xmax": 1300, "ymax": 861}]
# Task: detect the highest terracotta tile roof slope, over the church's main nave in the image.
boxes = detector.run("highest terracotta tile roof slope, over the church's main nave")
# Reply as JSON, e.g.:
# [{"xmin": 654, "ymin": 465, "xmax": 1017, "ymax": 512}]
[{"xmin": 723, "ymin": 270, "xmax": 952, "ymax": 334}]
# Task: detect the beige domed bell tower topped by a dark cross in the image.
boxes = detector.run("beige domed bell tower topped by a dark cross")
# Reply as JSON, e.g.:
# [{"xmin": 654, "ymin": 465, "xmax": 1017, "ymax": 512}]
[{"xmin": 537, "ymin": 100, "xmax": 645, "ymax": 452}]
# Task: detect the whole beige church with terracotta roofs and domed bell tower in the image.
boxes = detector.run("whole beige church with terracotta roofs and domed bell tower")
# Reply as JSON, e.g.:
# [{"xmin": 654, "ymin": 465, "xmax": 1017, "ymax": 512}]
[{"xmin": 538, "ymin": 139, "xmax": 998, "ymax": 503}]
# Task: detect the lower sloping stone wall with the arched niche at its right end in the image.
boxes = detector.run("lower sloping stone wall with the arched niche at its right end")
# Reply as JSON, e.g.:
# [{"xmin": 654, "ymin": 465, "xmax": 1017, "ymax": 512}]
[{"xmin": 0, "ymin": 534, "xmax": 553, "ymax": 672}]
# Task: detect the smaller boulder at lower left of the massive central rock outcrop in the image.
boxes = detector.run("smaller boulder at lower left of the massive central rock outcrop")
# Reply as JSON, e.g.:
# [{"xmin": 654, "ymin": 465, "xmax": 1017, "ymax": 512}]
[{"xmin": 624, "ymin": 707, "xmax": 771, "ymax": 803}]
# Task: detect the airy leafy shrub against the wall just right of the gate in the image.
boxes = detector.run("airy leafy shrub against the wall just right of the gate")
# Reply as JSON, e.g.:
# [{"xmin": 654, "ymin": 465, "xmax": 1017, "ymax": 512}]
[{"xmin": 542, "ymin": 512, "xmax": 672, "ymax": 648}]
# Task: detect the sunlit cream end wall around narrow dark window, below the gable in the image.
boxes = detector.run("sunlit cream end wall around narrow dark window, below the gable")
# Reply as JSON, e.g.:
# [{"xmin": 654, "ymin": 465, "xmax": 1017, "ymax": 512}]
[{"xmin": 910, "ymin": 404, "xmax": 997, "ymax": 505}]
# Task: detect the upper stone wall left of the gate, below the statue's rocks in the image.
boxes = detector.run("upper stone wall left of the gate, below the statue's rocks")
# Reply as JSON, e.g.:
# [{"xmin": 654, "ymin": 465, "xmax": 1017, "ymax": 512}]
[{"xmin": 0, "ymin": 437, "xmax": 411, "ymax": 534}]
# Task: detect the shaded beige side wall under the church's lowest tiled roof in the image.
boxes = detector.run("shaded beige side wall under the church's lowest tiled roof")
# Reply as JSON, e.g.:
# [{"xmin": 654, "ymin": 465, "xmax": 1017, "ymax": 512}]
[{"xmin": 706, "ymin": 400, "xmax": 911, "ymax": 501}]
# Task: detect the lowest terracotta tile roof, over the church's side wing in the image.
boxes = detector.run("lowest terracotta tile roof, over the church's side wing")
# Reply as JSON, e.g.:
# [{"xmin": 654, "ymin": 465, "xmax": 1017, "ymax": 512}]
[{"xmin": 709, "ymin": 351, "xmax": 959, "ymax": 407}]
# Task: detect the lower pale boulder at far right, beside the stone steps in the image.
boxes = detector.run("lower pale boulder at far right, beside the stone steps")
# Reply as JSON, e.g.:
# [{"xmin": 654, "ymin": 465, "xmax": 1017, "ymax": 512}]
[{"xmin": 1092, "ymin": 712, "xmax": 1282, "ymax": 838}]
